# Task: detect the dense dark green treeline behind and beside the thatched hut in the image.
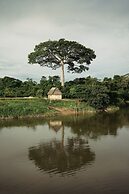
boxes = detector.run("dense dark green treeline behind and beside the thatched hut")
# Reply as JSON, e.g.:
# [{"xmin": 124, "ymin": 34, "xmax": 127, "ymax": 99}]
[{"xmin": 0, "ymin": 75, "xmax": 129, "ymax": 109}]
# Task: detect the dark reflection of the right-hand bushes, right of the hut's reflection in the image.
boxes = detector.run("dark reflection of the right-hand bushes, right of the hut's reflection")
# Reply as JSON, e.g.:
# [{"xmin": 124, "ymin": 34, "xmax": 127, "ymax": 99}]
[{"xmin": 50, "ymin": 109, "xmax": 129, "ymax": 139}]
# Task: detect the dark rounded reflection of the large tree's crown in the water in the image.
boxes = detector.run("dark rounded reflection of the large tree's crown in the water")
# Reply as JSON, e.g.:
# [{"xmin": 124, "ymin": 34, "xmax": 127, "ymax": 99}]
[{"xmin": 29, "ymin": 138, "xmax": 95, "ymax": 175}]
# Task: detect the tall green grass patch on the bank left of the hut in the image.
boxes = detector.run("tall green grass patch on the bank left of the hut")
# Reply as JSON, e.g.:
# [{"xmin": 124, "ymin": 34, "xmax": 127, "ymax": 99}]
[{"xmin": 0, "ymin": 99, "xmax": 51, "ymax": 117}]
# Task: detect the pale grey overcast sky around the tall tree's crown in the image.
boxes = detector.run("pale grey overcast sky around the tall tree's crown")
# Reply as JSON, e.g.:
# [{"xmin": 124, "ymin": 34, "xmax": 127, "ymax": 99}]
[{"xmin": 0, "ymin": 0, "xmax": 129, "ymax": 81}]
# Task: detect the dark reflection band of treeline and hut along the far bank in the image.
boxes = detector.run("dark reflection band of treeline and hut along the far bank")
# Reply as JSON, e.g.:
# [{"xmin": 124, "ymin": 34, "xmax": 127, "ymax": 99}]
[{"xmin": 0, "ymin": 109, "xmax": 129, "ymax": 139}]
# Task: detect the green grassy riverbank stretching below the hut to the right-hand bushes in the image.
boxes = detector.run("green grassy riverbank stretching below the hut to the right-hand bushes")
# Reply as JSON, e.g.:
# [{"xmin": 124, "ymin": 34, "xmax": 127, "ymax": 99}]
[{"xmin": 0, "ymin": 98, "xmax": 93, "ymax": 119}]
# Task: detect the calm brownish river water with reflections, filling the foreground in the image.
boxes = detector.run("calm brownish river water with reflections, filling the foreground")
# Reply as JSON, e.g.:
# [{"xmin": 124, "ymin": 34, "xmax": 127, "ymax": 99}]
[{"xmin": 0, "ymin": 110, "xmax": 129, "ymax": 194}]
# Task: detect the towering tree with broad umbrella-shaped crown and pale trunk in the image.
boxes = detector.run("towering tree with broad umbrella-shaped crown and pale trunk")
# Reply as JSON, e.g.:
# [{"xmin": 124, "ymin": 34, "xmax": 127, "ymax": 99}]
[{"xmin": 28, "ymin": 39, "xmax": 96, "ymax": 86}]
